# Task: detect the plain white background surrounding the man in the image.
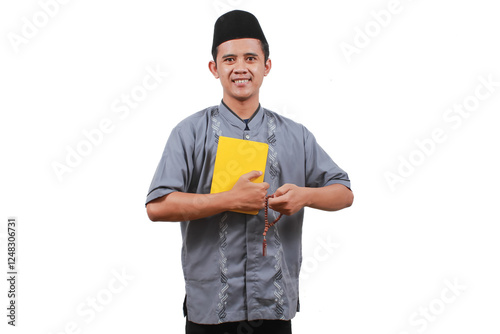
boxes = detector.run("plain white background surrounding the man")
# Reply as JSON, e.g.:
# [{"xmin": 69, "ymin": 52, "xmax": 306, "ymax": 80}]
[{"xmin": 0, "ymin": 0, "xmax": 500, "ymax": 334}]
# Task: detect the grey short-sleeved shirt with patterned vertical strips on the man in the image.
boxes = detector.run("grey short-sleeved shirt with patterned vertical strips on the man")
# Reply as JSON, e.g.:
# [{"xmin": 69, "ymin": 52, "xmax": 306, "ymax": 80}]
[{"xmin": 146, "ymin": 103, "xmax": 350, "ymax": 324}]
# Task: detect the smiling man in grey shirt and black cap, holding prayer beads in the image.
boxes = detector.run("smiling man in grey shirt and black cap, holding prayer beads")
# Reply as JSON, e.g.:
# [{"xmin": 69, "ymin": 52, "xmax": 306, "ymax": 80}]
[{"xmin": 146, "ymin": 11, "xmax": 353, "ymax": 333}]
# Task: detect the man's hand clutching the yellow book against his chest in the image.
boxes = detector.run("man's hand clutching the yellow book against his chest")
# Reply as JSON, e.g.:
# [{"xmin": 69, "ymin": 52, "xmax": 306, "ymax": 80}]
[{"xmin": 228, "ymin": 170, "xmax": 269, "ymax": 211}]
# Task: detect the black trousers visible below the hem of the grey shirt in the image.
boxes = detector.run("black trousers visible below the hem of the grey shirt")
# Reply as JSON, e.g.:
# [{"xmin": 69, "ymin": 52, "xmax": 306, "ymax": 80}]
[{"xmin": 186, "ymin": 317, "xmax": 292, "ymax": 334}]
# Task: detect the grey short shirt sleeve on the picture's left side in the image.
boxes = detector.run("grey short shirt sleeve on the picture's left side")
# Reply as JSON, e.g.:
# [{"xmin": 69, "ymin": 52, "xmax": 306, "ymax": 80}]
[{"xmin": 146, "ymin": 126, "xmax": 194, "ymax": 204}]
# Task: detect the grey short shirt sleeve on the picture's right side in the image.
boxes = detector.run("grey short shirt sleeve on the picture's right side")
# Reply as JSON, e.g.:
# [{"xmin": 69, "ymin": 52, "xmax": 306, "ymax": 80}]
[{"xmin": 304, "ymin": 128, "xmax": 351, "ymax": 189}]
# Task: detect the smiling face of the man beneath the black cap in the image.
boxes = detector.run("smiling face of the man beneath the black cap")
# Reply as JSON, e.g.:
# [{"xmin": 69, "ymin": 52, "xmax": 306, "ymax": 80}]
[{"xmin": 209, "ymin": 38, "xmax": 271, "ymax": 102}]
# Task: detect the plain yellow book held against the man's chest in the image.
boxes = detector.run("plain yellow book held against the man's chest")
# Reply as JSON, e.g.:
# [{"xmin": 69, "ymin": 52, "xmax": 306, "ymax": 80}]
[{"xmin": 210, "ymin": 136, "xmax": 269, "ymax": 215}]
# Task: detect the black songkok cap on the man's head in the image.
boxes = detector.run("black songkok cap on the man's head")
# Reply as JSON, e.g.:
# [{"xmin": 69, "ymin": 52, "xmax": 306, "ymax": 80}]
[{"xmin": 212, "ymin": 10, "xmax": 267, "ymax": 53}]
